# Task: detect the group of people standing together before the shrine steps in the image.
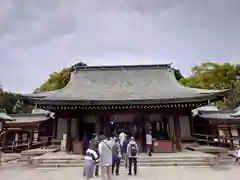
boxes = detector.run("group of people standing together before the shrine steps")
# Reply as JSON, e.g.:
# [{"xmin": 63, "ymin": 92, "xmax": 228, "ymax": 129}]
[{"xmin": 83, "ymin": 132, "xmax": 139, "ymax": 180}]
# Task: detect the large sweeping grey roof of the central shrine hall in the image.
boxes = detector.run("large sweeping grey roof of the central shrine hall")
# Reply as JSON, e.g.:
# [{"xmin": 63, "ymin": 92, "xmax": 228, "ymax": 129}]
[{"xmin": 24, "ymin": 64, "xmax": 227, "ymax": 104}]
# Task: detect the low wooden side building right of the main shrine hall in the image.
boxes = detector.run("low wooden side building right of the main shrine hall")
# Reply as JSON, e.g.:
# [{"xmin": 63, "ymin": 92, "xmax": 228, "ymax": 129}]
[{"xmin": 194, "ymin": 109, "xmax": 240, "ymax": 148}]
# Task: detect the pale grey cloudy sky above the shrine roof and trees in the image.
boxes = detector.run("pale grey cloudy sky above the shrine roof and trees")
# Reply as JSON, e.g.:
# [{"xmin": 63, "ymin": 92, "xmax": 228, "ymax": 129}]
[{"xmin": 0, "ymin": 0, "xmax": 240, "ymax": 93}]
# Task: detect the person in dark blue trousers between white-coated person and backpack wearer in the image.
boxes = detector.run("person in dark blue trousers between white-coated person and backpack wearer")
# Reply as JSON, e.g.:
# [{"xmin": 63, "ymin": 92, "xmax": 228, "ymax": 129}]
[{"xmin": 112, "ymin": 138, "xmax": 122, "ymax": 176}]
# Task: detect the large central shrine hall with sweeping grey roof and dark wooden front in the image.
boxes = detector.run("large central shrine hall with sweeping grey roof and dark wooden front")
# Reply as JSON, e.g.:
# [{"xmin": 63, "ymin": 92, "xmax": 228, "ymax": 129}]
[{"xmin": 23, "ymin": 64, "xmax": 227, "ymax": 152}]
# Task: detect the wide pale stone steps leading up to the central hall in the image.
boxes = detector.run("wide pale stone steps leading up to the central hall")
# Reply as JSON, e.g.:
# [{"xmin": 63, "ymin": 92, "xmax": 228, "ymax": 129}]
[{"xmin": 29, "ymin": 151, "xmax": 218, "ymax": 168}]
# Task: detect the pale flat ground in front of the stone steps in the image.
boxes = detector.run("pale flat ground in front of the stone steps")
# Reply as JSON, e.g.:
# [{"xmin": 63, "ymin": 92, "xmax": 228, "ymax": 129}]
[{"xmin": 0, "ymin": 164, "xmax": 240, "ymax": 180}]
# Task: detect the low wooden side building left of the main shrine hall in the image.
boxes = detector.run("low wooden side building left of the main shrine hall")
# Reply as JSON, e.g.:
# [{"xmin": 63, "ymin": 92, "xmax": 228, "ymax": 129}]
[{"xmin": 0, "ymin": 109, "xmax": 53, "ymax": 152}]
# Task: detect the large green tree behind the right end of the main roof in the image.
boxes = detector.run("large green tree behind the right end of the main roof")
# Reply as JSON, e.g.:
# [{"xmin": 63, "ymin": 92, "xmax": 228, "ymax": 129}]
[{"xmin": 180, "ymin": 62, "xmax": 240, "ymax": 108}]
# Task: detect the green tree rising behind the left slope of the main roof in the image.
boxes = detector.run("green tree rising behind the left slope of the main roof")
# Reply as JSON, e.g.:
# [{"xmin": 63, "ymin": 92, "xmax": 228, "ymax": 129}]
[{"xmin": 35, "ymin": 62, "xmax": 86, "ymax": 92}]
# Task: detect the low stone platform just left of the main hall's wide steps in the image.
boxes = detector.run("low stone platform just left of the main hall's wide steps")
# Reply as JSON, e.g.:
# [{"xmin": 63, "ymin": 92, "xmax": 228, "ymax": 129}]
[{"xmin": 19, "ymin": 148, "xmax": 58, "ymax": 161}]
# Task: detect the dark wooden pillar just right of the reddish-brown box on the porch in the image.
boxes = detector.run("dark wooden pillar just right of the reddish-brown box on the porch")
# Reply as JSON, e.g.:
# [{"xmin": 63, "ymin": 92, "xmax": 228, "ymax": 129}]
[{"xmin": 173, "ymin": 115, "xmax": 182, "ymax": 151}]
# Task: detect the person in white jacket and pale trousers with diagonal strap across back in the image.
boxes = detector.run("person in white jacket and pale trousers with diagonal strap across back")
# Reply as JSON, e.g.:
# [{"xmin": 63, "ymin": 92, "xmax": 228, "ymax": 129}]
[{"xmin": 98, "ymin": 135, "xmax": 113, "ymax": 180}]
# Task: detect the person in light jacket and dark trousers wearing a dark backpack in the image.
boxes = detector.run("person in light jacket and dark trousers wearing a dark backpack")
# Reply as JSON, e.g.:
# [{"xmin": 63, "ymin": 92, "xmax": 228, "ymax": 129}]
[{"xmin": 127, "ymin": 137, "xmax": 139, "ymax": 176}]
